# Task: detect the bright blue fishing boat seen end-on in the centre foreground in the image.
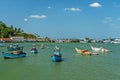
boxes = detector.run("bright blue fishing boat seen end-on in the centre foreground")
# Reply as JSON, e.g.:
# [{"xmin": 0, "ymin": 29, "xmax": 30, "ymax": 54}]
[{"xmin": 51, "ymin": 46, "xmax": 62, "ymax": 62}]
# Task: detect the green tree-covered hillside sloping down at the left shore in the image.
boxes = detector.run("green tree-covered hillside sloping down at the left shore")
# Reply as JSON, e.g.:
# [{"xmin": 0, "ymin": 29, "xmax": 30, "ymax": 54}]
[{"xmin": 0, "ymin": 21, "xmax": 37, "ymax": 39}]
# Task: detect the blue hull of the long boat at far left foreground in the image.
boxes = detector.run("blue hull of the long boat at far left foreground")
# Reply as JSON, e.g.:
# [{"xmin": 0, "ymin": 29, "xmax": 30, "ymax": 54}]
[{"xmin": 2, "ymin": 52, "xmax": 26, "ymax": 59}]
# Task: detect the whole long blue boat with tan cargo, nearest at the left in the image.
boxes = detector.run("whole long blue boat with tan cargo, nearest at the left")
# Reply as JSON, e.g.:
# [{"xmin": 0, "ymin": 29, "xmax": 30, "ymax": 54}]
[{"xmin": 2, "ymin": 51, "xmax": 26, "ymax": 59}]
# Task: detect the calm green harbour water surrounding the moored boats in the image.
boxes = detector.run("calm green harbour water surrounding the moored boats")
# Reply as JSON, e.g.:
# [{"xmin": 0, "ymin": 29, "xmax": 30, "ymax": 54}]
[{"xmin": 0, "ymin": 43, "xmax": 120, "ymax": 80}]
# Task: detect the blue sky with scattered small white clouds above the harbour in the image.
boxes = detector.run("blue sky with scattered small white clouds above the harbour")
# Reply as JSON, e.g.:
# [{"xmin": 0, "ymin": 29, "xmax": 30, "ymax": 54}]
[{"xmin": 0, "ymin": 0, "xmax": 120, "ymax": 39}]
